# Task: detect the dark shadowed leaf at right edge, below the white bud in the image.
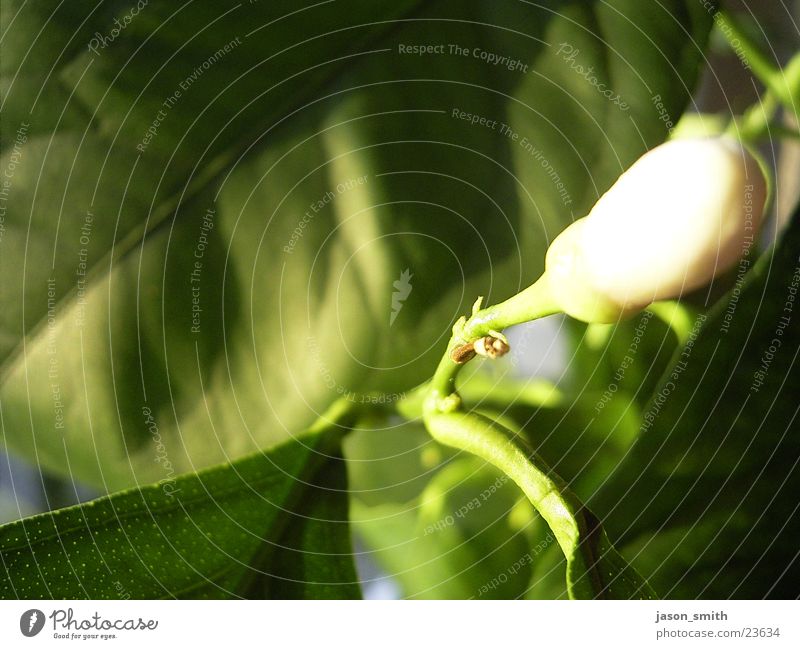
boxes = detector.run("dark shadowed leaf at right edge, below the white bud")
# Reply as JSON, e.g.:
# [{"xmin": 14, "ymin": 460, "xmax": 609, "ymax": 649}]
[{"xmin": 592, "ymin": 204, "xmax": 800, "ymax": 599}]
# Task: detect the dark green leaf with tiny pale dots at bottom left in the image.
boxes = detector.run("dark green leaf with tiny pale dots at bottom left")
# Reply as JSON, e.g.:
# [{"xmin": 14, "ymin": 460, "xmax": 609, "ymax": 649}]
[{"xmin": 0, "ymin": 433, "xmax": 360, "ymax": 599}]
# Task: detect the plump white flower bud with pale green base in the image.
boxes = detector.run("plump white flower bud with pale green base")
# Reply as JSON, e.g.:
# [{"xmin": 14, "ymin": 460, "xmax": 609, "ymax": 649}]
[{"xmin": 545, "ymin": 137, "xmax": 766, "ymax": 322}]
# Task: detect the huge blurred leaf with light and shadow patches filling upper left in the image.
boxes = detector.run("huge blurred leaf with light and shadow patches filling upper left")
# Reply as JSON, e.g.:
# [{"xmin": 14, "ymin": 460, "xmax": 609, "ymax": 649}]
[{"xmin": 0, "ymin": 0, "xmax": 710, "ymax": 491}]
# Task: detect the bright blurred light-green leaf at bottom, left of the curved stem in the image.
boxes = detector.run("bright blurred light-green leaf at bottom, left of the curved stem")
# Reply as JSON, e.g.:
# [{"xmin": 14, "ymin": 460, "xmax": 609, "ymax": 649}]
[{"xmin": 353, "ymin": 458, "xmax": 540, "ymax": 599}]
